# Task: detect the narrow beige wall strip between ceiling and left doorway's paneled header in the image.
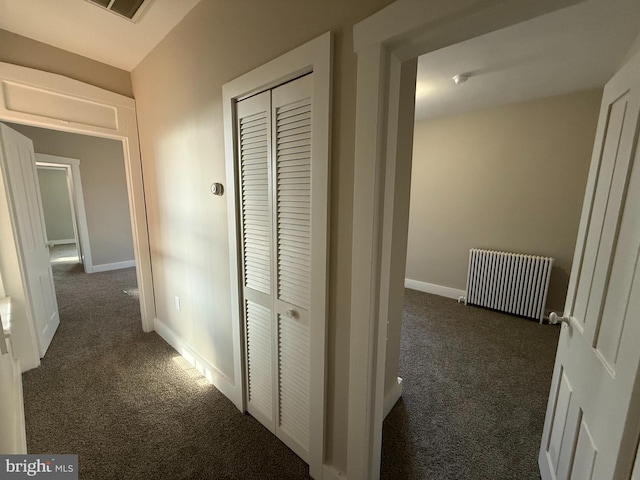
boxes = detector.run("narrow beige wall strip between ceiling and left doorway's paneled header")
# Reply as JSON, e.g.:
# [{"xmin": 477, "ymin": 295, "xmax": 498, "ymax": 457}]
[{"xmin": 0, "ymin": 30, "xmax": 133, "ymax": 97}]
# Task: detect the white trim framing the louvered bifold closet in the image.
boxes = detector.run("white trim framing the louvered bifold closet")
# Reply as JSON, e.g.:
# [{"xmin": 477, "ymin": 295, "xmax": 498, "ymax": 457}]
[{"xmin": 222, "ymin": 32, "xmax": 332, "ymax": 479}]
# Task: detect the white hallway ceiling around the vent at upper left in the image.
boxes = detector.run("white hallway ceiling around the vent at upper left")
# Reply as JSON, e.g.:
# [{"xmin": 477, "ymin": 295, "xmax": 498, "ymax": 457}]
[{"xmin": 0, "ymin": 0, "xmax": 200, "ymax": 71}]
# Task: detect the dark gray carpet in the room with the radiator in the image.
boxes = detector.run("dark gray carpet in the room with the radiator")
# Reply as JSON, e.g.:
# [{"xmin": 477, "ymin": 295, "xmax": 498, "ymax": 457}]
[{"xmin": 381, "ymin": 290, "xmax": 559, "ymax": 480}]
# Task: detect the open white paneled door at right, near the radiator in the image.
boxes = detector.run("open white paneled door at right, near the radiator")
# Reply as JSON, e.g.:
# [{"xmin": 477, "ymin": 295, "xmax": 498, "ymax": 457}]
[{"xmin": 539, "ymin": 50, "xmax": 640, "ymax": 480}]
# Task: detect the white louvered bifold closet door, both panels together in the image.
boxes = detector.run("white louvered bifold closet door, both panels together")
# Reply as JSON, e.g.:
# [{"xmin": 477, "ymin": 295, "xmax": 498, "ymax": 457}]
[{"xmin": 237, "ymin": 74, "xmax": 312, "ymax": 461}]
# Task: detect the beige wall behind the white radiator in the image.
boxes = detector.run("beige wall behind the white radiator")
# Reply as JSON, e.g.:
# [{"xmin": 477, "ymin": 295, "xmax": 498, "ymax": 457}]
[{"xmin": 406, "ymin": 90, "xmax": 602, "ymax": 311}]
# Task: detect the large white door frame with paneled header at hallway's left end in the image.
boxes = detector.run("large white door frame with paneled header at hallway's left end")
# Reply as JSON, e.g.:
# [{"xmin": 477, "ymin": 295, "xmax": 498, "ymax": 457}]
[{"xmin": 0, "ymin": 62, "xmax": 155, "ymax": 372}]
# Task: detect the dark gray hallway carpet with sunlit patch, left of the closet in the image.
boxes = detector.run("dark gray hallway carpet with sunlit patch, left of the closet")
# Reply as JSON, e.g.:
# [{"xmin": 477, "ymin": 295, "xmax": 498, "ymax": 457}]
[{"xmin": 23, "ymin": 263, "xmax": 308, "ymax": 480}]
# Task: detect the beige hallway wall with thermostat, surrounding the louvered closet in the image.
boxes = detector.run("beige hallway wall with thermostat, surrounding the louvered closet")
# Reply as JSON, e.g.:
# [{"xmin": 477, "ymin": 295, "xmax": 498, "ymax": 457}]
[{"xmin": 132, "ymin": 0, "xmax": 390, "ymax": 471}]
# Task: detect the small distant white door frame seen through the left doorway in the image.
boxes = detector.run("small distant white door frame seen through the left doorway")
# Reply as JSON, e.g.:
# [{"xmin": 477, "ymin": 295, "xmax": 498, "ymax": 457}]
[{"xmin": 36, "ymin": 153, "xmax": 93, "ymax": 273}]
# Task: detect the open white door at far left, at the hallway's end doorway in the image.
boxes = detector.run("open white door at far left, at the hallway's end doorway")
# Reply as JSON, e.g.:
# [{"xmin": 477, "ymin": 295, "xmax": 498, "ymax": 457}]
[{"xmin": 0, "ymin": 124, "xmax": 60, "ymax": 357}]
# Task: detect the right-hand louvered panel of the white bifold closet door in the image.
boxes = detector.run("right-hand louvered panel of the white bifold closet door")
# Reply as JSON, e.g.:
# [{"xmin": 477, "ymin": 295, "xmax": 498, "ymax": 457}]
[{"xmin": 271, "ymin": 75, "xmax": 312, "ymax": 459}]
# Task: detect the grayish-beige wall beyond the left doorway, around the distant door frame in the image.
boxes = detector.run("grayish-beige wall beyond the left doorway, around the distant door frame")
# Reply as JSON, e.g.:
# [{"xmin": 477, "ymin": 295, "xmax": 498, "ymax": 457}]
[{"xmin": 9, "ymin": 124, "xmax": 134, "ymax": 266}]
